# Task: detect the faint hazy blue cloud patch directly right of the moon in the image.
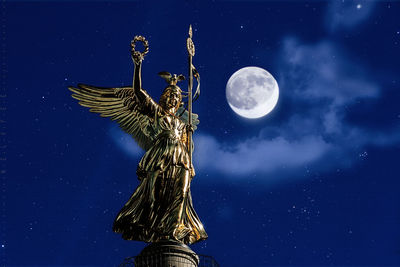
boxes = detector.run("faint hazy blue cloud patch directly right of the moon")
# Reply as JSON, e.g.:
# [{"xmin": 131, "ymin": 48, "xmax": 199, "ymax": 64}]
[{"xmin": 282, "ymin": 38, "xmax": 379, "ymax": 106}]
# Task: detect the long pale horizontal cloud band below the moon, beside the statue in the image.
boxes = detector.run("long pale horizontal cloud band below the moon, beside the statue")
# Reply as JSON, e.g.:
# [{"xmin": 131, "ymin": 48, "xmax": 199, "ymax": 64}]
[{"xmin": 194, "ymin": 134, "xmax": 331, "ymax": 178}]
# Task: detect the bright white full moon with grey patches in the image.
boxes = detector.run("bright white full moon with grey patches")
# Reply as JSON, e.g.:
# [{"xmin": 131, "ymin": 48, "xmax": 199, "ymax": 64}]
[{"xmin": 226, "ymin": 67, "xmax": 279, "ymax": 119}]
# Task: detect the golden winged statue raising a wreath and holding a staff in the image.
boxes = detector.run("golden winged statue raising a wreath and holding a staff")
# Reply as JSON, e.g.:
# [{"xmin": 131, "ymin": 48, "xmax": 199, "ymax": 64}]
[{"xmin": 69, "ymin": 28, "xmax": 207, "ymax": 244}]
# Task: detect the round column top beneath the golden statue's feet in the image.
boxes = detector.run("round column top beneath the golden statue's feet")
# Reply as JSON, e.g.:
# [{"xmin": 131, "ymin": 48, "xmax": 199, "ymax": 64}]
[{"xmin": 135, "ymin": 240, "xmax": 199, "ymax": 267}]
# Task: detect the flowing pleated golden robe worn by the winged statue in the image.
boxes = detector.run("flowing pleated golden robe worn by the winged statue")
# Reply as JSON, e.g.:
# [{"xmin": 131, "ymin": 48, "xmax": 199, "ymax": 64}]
[{"xmin": 113, "ymin": 92, "xmax": 207, "ymax": 244}]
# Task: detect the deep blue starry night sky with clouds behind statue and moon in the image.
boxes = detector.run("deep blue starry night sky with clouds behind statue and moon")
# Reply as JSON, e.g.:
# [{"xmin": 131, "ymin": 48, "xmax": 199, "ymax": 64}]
[{"xmin": 0, "ymin": 0, "xmax": 400, "ymax": 267}]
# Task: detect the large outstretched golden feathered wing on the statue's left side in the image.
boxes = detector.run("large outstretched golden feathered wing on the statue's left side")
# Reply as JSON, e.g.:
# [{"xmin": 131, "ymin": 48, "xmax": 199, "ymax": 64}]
[{"xmin": 68, "ymin": 84, "xmax": 154, "ymax": 151}]
